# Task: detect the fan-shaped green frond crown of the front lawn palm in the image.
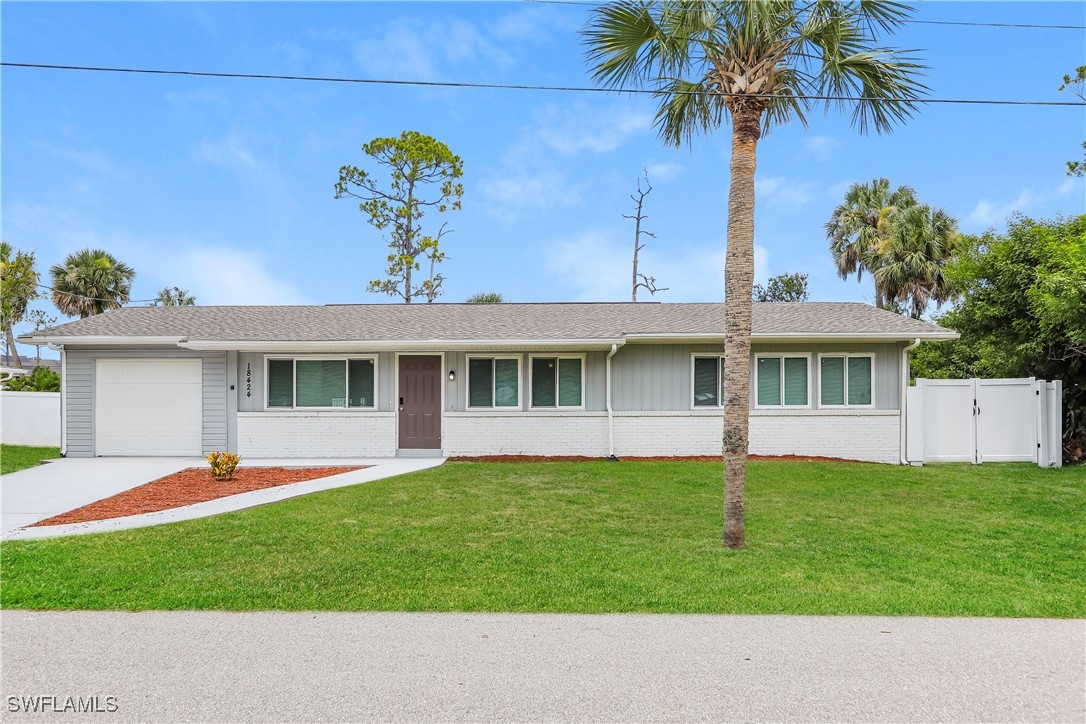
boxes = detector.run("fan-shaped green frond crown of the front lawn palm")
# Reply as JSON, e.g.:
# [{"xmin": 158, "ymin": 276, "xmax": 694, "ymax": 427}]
[{"xmin": 582, "ymin": 0, "xmax": 927, "ymax": 143}]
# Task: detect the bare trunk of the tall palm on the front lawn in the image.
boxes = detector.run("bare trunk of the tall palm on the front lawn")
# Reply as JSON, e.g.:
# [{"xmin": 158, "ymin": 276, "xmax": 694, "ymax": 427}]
[{"xmin": 723, "ymin": 106, "xmax": 762, "ymax": 548}]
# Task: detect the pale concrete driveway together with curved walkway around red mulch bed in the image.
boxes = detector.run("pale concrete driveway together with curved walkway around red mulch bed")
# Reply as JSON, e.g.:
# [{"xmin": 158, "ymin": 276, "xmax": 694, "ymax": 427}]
[{"xmin": 0, "ymin": 458, "xmax": 444, "ymax": 541}]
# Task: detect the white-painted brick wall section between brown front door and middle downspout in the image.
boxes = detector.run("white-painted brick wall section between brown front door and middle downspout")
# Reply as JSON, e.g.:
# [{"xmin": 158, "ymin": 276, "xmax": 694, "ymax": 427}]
[{"xmin": 441, "ymin": 411, "xmax": 607, "ymax": 457}]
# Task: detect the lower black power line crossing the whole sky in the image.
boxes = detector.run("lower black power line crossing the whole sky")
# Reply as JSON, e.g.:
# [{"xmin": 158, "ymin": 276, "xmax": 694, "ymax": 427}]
[{"xmin": 0, "ymin": 61, "xmax": 1086, "ymax": 106}]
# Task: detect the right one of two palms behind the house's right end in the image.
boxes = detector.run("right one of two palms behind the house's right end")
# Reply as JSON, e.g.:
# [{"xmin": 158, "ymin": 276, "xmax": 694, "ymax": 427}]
[{"xmin": 874, "ymin": 204, "xmax": 958, "ymax": 319}]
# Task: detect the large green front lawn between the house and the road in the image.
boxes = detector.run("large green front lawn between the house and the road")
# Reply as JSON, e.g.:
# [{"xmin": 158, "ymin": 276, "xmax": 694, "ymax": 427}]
[{"xmin": 0, "ymin": 461, "xmax": 1086, "ymax": 617}]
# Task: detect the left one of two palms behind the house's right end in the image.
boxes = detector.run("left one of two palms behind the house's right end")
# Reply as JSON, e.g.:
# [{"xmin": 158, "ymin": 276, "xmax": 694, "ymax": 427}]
[{"xmin": 825, "ymin": 178, "xmax": 918, "ymax": 308}]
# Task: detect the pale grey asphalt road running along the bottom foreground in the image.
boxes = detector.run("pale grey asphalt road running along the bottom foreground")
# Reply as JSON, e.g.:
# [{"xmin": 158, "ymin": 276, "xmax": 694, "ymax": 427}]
[{"xmin": 0, "ymin": 611, "xmax": 1086, "ymax": 722}]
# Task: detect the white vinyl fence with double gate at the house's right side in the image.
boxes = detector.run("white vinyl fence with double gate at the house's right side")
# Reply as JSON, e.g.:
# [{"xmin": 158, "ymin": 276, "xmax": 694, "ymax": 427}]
[{"xmin": 906, "ymin": 378, "xmax": 1063, "ymax": 468}]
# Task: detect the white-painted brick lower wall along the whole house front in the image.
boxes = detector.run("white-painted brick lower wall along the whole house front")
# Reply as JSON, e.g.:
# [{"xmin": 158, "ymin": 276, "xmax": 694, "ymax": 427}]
[{"xmin": 238, "ymin": 410, "xmax": 899, "ymax": 462}]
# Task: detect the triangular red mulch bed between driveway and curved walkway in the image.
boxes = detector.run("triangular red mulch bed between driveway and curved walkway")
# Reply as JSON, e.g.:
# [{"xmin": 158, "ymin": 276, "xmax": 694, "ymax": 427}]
[{"xmin": 34, "ymin": 466, "xmax": 362, "ymax": 526}]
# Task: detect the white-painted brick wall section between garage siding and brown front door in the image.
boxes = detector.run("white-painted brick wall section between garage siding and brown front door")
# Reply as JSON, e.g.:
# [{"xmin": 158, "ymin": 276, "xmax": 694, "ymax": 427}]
[{"xmin": 238, "ymin": 411, "xmax": 396, "ymax": 458}]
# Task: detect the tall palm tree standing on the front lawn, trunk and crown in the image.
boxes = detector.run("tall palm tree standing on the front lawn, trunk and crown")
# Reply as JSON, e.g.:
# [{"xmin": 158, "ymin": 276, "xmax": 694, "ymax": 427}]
[{"xmin": 583, "ymin": 0, "xmax": 925, "ymax": 548}]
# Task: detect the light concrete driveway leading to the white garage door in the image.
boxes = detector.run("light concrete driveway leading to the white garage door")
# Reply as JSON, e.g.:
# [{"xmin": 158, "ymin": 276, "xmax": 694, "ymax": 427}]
[{"xmin": 0, "ymin": 458, "xmax": 200, "ymax": 536}]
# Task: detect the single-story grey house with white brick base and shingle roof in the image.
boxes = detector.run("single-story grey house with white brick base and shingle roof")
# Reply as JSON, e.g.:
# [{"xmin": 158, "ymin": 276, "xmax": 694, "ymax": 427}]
[{"xmin": 21, "ymin": 303, "xmax": 957, "ymax": 462}]
